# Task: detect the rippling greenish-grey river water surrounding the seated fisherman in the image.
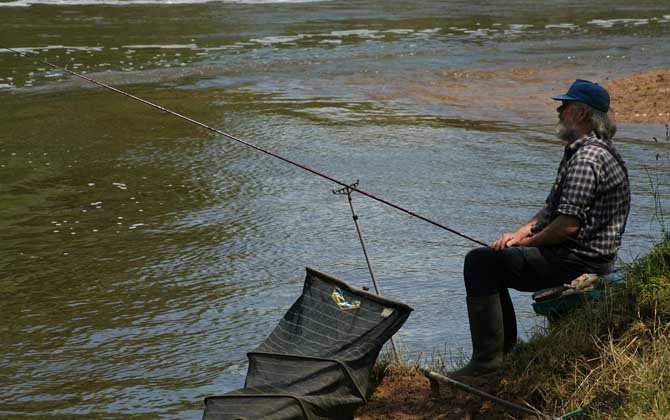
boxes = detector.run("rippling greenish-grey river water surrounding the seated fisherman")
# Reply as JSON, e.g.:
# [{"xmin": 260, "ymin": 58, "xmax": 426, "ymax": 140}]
[{"xmin": 0, "ymin": 0, "xmax": 670, "ymax": 419}]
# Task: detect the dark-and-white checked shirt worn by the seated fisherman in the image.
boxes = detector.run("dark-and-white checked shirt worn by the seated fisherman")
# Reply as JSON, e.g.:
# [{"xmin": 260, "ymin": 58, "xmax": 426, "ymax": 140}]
[{"xmin": 531, "ymin": 134, "xmax": 630, "ymax": 259}]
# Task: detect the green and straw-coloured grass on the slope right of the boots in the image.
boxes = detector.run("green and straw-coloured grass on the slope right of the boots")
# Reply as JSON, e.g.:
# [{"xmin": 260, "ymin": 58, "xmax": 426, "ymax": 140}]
[{"xmin": 500, "ymin": 240, "xmax": 670, "ymax": 419}]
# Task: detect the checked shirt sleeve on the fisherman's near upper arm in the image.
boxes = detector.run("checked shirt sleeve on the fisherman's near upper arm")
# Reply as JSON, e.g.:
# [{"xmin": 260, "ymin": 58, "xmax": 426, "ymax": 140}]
[{"xmin": 557, "ymin": 155, "xmax": 601, "ymax": 226}]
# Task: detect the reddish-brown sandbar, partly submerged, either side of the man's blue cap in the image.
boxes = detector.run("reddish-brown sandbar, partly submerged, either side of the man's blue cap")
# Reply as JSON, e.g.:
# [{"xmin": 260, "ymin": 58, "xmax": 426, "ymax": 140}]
[{"xmin": 384, "ymin": 68, "xmax": 670, "ymax": 124}]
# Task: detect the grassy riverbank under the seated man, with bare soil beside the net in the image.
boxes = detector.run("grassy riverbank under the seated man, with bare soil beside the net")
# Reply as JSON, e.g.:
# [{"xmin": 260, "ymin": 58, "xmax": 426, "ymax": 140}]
[{"xmin": 358, "ymin": 240, "xmax": 670, "ymax": 419}]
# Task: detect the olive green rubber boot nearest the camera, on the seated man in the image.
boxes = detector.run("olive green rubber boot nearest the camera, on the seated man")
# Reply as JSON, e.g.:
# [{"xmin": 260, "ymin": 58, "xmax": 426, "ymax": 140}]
[{"xmin": 447, "ymin": 293, "xmax": 505, "ymax": 377}]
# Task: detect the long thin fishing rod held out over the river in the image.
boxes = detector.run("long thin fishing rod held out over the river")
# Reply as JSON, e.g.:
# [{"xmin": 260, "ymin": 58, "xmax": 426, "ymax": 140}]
[{"xmin": 0, "ymin": 46, "xmax": 488, "ymax": 246}]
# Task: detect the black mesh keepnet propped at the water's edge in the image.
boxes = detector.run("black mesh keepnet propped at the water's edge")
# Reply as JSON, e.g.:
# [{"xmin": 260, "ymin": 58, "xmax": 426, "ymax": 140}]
[{"xmin": 203, "ymin": 268, "xmax": 412, "ymax": 420}]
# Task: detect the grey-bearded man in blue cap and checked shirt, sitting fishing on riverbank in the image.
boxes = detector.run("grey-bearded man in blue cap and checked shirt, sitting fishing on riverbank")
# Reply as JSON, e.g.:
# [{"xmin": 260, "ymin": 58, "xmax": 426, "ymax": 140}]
[{"xmin": 451, "ymin": 79, "xmax": 630, "ymax": 376}]
